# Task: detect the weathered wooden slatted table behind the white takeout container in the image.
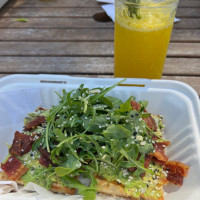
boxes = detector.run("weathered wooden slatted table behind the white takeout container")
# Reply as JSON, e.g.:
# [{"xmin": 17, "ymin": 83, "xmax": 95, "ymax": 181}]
[{"xmin": 0, "ymin": 0, "xmax": 200, "ymax": 95}]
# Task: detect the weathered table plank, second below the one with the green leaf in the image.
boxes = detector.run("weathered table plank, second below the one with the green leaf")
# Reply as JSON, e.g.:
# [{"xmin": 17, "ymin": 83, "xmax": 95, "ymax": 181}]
[{"xmin": 0, "ymin": 42, "xmax": 200, "ymax": 57}]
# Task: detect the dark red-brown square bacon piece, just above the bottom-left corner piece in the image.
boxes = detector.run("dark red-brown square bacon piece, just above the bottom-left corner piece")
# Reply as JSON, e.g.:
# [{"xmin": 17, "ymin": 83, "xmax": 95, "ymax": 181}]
[{"xmin": 9, "ymin": 131, "xmax": 34, "ymax": 156}]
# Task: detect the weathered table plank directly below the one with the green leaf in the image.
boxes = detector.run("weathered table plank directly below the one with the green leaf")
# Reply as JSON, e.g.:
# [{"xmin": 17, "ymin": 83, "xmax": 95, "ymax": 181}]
[{"xmin": 0, "ymin": 29, "xmax": 200, "ymax": 42}]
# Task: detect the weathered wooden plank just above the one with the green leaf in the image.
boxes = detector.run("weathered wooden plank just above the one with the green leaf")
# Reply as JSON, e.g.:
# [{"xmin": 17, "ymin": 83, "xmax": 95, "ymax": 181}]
[{"xmin": 0, "ymin": 7, "xmax": 200, "ymax": 17}]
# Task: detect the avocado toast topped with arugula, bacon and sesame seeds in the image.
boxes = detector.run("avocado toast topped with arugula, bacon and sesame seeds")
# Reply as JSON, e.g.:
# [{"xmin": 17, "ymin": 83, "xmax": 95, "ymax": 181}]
[{"xmin": 1, "ymin": 80, "xmax": 188, "ymax": 200}]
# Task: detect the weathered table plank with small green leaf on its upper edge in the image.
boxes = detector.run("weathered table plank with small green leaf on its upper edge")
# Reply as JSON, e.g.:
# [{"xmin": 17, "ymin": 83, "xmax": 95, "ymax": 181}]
[{"xmin": 0, "ymin": 18, "xmax": 200, "ymax": 29}]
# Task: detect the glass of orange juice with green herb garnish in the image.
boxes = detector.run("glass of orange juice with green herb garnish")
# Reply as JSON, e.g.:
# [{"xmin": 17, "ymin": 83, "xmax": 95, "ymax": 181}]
[{"xmin": 114, "ymin": 0, "xmax": 178, "ymax": 79}]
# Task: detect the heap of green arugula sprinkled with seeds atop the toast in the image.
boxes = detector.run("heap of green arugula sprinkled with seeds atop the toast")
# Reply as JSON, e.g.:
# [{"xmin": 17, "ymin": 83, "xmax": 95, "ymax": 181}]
[{"xmin": 25, "ymin": 80, "xmax": 164, "ymax": 200}]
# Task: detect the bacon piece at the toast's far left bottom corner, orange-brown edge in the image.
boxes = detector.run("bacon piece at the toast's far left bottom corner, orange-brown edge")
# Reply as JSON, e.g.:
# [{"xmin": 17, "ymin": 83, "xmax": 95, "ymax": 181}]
[{"xmin": 1, "ymin": 156, "xmax": 28, "ymax": 180}]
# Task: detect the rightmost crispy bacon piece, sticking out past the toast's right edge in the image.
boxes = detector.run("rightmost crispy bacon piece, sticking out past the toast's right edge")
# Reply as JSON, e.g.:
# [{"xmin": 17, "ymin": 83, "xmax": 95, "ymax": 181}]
[{"xmin": 164, "ymin": 161, "xmax": 189, "ymax": 186}]
